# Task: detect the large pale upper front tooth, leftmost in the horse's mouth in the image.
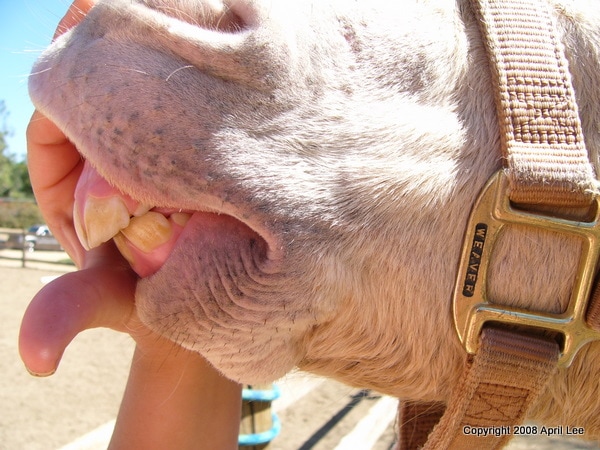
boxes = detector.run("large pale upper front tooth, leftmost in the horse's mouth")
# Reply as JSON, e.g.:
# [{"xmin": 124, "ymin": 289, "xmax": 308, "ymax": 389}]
[{"xmin": 75, "ymin": 197, "xmax": 129, "ymax": 250}]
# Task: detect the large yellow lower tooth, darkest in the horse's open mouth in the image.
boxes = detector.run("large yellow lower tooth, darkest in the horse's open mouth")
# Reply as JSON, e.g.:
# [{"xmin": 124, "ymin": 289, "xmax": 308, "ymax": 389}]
[{"xmin": 121, "ymin": 211, "xmax": 172, "ymax": 253}]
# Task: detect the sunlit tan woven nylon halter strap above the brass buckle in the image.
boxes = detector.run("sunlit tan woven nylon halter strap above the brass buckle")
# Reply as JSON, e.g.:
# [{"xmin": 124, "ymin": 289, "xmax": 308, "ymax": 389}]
[{"xmin": 480, "ymin": 0, "xmax": 594, "ymax": 207}]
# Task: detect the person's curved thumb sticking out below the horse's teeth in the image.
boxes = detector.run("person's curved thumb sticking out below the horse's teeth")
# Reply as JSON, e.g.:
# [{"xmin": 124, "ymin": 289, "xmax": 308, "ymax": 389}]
[{"xmin": 19, "ymin": 253, "xmax": 141, "ymax": 376}]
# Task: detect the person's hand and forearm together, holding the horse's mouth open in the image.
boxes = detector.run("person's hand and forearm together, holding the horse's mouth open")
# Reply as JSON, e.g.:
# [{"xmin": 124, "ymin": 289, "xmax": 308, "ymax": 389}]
[{"xmin": 19, "ymin": 0, "xmax": 241, "ymax": 449}]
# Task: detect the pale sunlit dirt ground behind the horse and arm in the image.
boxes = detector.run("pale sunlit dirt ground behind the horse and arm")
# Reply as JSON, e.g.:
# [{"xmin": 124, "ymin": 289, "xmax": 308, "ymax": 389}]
[{"xmin": 0, "ymin": 251, "xmax": 600, "ymax": 450}]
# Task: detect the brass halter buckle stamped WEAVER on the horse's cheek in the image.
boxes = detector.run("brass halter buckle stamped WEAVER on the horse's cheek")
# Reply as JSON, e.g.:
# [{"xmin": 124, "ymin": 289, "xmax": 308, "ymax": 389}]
[{"xmin": 453, "ymin": 171, "xmax": 600, "ymax": 367}]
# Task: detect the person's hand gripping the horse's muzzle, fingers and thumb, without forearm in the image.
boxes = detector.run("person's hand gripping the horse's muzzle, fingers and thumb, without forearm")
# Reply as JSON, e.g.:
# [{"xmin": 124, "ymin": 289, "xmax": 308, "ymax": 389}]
[{"xmin": 20, "ymin": 0, "xmax": 192, "ymax": 375}]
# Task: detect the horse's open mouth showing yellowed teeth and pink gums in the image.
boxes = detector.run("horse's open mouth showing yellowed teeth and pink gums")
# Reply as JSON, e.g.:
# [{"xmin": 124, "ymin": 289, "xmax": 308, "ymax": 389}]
[{"xmin": 73, "ymin": 161, "xmax": 268, "ymax": 278}]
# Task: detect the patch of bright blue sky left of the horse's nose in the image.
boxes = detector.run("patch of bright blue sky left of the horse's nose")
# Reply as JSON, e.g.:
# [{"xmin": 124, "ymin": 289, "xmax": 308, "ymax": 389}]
[{"xmin": 0, "ymin": 0, "xmax": 71, "ymax": 159}]
